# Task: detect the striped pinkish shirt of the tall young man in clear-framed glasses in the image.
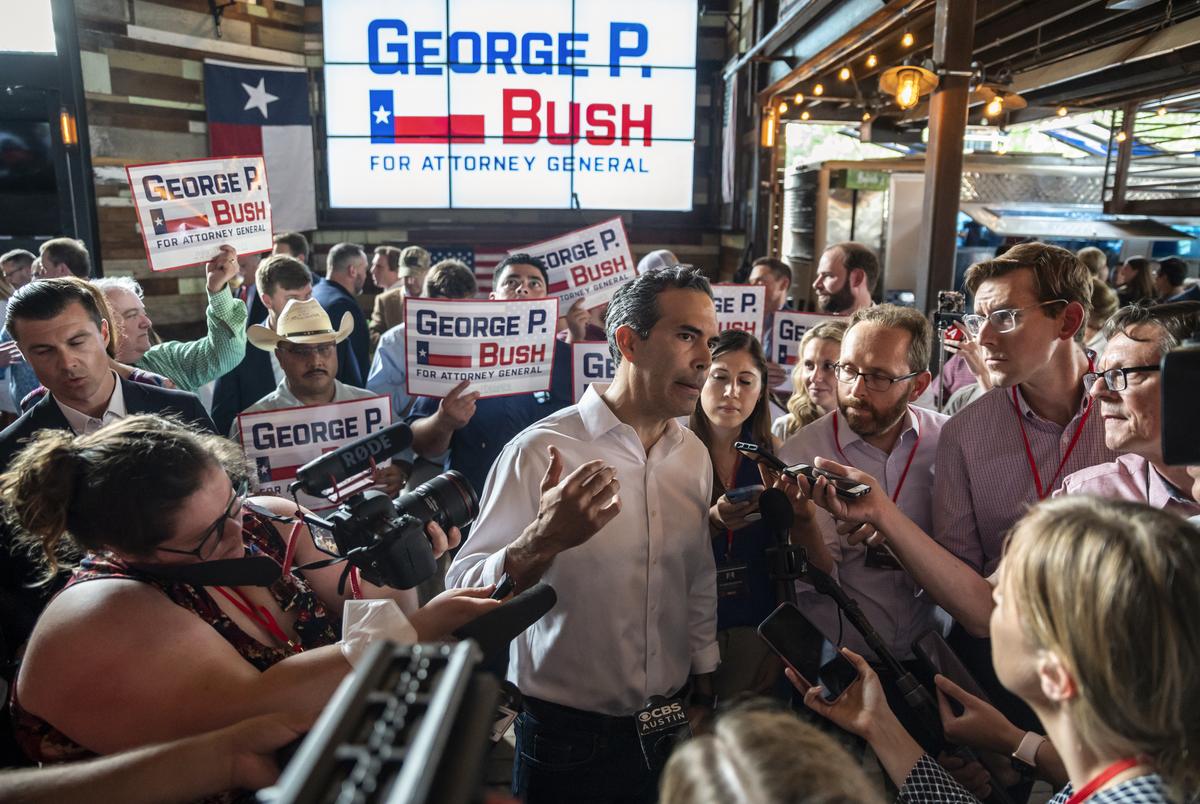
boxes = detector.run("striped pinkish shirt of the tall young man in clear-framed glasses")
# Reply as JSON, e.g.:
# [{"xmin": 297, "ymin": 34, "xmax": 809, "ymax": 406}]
[{"xmin": 934, "ymin": 388, "xmax": 1116, "ymax": 576}]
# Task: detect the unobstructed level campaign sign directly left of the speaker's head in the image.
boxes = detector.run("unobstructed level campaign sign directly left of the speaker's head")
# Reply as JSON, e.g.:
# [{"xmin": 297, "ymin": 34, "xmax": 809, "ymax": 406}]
[{"xmin": 404, "ymin": 299, "xmax": 558, "ymax": 398}]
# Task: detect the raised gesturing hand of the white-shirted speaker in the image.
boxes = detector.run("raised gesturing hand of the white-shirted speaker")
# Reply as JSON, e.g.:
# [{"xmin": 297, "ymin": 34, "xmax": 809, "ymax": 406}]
[{"xmin": 536, "ymin": 446, "xmax": 620, "ymax": 553}]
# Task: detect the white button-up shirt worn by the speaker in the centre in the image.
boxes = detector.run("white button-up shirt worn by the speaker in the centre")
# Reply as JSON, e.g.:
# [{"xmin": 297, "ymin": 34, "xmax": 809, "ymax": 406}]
[{"xmin": 446, "ymin": 384, "xmax": 720, "ymax": 715}]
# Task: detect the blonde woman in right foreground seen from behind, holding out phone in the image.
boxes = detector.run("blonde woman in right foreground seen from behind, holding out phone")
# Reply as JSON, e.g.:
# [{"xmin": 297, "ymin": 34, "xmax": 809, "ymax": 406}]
[{"xmin": 792, "ymin": 496, "xmax": 1200, "ymax": 804}]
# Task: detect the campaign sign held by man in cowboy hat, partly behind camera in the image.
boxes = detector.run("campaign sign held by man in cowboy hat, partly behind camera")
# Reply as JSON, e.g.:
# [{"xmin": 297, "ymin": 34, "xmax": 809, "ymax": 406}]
[{"xmin": 238, "ymin": 396, "xmax": 391, "ymax": 511}]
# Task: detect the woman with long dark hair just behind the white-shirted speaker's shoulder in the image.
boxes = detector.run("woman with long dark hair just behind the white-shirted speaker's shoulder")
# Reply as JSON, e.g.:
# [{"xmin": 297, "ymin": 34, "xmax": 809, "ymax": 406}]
[{"xmin": 690, "ymin": 330, "xmax": 781, "ymax": 698}]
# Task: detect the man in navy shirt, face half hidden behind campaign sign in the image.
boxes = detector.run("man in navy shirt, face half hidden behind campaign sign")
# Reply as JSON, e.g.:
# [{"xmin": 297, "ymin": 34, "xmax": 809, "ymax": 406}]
[{"xmin": 408, "ymin": 253, "xmax": 574, "ymax": 492}]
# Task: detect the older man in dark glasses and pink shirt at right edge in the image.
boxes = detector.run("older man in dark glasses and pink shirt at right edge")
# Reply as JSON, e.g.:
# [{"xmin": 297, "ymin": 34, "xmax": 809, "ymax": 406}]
[{"xmin": 1055, "ymin": 301, "xmax": 1200, "ymax": 517}]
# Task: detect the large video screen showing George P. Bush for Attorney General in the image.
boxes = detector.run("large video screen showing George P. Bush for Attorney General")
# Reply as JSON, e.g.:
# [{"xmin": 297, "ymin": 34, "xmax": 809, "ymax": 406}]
[{"xmin": 323, "ymin": 0, "xmax": 697, "ymax": 210}]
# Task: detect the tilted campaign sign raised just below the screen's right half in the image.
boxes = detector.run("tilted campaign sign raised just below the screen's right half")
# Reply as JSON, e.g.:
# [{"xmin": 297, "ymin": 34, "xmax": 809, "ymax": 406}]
[{"xmin": 509, "ymin": 217, "xmax": 637, "ymax": 313}]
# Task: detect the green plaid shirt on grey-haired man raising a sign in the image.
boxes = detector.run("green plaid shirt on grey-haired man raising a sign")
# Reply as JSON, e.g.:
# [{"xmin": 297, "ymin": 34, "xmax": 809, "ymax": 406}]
[{"xmin": 136, "ymin": 286, "xmax": 246, "ymax": 391}]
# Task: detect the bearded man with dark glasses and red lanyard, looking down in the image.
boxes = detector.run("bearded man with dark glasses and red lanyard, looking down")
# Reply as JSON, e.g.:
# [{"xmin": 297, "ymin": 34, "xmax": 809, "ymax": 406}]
[{"xmin": 779, "ymin": 305, "xmax": 948, "ymax": 691}]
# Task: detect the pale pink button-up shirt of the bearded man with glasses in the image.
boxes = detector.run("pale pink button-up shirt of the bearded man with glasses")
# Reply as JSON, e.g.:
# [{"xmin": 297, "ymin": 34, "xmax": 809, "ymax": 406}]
[{"xmin": 779, "ymin": 404, "xmax": 948, "ymax": 660}]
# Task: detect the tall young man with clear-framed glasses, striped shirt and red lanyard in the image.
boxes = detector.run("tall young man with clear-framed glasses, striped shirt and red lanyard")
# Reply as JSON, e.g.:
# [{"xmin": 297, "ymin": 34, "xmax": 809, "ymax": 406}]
[{"xmin": 934, "ymin": 242, "xmax": 1116, "ymax": 576}]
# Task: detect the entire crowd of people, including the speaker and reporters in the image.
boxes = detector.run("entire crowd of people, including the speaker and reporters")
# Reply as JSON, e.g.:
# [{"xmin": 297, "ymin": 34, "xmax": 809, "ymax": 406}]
[{"xmin": 0, "ymin": 234, "xmax": 1200, "ymax": 804}]
